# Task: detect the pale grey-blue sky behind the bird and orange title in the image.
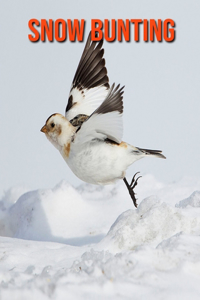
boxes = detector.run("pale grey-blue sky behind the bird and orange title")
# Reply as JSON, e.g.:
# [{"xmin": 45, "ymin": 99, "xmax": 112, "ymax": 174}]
[{"xmin": 0, "ymin": 0, "xmax": 200, "ymax": 195}]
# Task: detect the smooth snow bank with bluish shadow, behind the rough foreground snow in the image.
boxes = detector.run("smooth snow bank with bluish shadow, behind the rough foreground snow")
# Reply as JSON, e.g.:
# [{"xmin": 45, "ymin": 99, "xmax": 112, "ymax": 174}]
[{"xmin": 0, "ymin": 181, "xmax": 133, "ymax": 246}]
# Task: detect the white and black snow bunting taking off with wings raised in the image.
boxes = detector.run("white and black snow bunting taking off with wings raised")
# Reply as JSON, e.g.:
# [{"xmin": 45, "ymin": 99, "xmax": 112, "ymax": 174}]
[{"xmin": 41, "ymin": 33, "xmax": 165, "ymax": 207}]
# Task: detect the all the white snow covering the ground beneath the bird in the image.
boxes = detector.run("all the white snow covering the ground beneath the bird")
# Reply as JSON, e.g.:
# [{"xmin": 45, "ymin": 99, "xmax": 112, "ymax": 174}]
[{"xmin": 0, "ymin": 175, "xmax": 200, "ymax": 300}]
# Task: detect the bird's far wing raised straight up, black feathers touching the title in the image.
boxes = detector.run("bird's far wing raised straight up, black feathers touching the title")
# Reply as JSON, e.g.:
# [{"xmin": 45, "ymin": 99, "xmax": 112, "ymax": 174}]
[{"xmin": 65, "ymin": 32, "xmax": 109, "ymax": 121}]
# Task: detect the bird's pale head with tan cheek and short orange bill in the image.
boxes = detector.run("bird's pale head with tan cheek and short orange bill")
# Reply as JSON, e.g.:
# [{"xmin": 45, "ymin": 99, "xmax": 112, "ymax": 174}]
[{"xmin": 40, "ymin": 113, "xmax": 76, "ymax": 150}]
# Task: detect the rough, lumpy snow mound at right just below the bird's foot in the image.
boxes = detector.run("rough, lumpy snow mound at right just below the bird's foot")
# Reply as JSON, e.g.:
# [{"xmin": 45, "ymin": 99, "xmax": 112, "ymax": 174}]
[{"xmin": 102, "ymin": 193, "xmax": 200, "ymax": 251}]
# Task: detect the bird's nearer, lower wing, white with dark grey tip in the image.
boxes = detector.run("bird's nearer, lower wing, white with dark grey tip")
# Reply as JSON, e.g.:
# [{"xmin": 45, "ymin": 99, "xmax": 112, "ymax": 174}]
[{"xmin": 74, "ymin": 84, "xmax": 124, "ymax": 144}]
